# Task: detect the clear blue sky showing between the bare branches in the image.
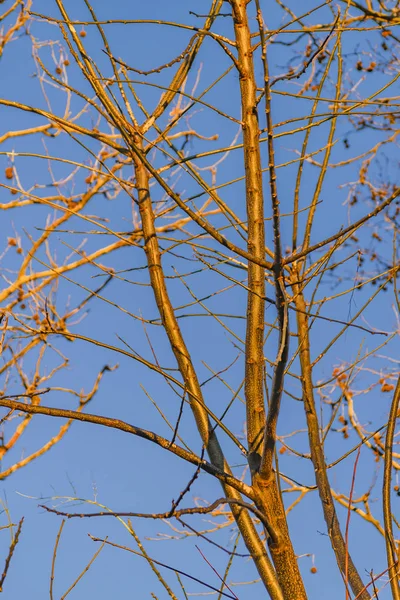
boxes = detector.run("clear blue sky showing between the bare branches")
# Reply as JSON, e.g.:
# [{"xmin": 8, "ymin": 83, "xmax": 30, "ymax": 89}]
[{"xmin": 0, "ymin": 0, "xmax": 398, "ymax": 600}]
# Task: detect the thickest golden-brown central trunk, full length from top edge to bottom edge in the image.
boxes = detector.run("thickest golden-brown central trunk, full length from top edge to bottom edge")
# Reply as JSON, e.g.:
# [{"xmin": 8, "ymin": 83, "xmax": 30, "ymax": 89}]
[{"xmin": 230, "ymin": 0, "xmax": 307, "ymax": 600}]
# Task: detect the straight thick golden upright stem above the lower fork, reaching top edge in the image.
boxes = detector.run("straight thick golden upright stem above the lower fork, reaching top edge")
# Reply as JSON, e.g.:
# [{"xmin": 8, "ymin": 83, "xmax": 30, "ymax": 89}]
[{"xmin": 231, "ymin": 2, "xmax": 265, "ymax": 472}]
